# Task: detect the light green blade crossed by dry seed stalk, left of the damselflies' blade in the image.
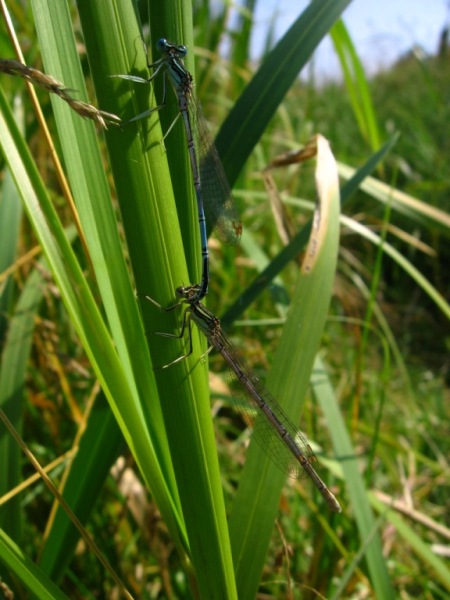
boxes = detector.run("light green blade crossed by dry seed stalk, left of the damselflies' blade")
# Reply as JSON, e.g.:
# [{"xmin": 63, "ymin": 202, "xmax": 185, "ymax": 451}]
[{"xmin": 28, "ymin": 2, "xmax": 187, "ymax": 552}]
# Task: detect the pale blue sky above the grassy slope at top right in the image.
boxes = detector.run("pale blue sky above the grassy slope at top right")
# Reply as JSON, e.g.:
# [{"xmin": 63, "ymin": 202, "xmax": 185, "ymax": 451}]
[{"xmin": 253, "ymin": 0, "xmax": 450, "ymax": 79}]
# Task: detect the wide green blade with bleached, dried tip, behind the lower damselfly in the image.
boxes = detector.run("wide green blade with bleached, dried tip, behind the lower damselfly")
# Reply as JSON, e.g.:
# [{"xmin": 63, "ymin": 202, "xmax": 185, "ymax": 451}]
[{"xmin": 230, "ymin": 136, "xmax": 339, "ymax": 599}]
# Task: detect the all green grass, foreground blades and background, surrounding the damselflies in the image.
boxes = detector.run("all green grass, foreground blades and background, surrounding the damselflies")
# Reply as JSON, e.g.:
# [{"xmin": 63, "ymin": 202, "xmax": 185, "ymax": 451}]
[{"xmin": 0, "ymin": 0, "xmax": 450, "ymax": 600}]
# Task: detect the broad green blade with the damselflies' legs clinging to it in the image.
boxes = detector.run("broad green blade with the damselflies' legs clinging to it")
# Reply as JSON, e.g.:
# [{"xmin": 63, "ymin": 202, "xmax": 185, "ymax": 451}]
[{"xmin": 74, "ymin": 2, "xmax": 235, "ymax": 598}]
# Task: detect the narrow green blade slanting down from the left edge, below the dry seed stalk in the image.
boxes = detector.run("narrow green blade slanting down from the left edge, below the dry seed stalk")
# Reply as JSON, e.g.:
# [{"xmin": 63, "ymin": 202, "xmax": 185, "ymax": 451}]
[{"xmin": 0, "ymin": 79, "xmax": 186, "ymax": 568}]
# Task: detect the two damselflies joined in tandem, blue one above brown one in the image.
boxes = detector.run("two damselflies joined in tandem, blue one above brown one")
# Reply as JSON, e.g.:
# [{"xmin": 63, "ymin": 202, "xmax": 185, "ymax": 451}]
[{"xmin": 117, "ymin": 38, "xmax": 341, "ymax": 512}]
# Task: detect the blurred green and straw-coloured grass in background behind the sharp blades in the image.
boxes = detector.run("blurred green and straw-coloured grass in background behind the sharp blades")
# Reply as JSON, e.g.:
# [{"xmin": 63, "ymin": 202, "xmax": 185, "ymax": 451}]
[{"xmin": 0, "ymin": 2, "xmax": 450, "ymax": 598}]
